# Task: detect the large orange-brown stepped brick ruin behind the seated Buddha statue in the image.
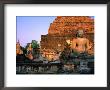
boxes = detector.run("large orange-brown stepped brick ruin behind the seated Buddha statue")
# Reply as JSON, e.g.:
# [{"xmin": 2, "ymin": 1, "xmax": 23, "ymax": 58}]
[{"xmin": 40, "ymin": 16, "xmax": 94, "ymax": 59}]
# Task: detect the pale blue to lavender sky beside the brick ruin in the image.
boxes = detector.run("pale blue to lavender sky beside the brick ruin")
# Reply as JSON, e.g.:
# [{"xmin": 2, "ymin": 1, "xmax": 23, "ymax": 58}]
[{"xmin": 16, "ymin": 16, "xmax": 94, "ymax": 47}]
